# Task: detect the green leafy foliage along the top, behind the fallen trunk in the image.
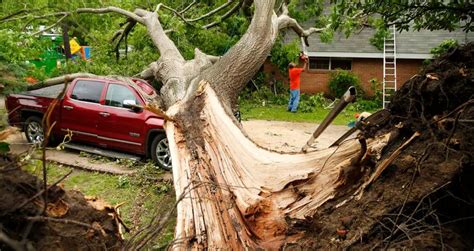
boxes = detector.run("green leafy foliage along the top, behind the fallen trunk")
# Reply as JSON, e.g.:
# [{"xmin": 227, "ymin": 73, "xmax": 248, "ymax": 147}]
[{"xmin": 0, "ymin": 0, "xmax": 474, "ymax": 84}]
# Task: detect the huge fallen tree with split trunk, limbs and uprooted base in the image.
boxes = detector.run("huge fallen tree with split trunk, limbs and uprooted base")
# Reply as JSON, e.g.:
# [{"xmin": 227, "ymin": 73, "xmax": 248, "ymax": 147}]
[{"xmin": 1, "ymin": 0, "xmax": 473, "ymax": 249}]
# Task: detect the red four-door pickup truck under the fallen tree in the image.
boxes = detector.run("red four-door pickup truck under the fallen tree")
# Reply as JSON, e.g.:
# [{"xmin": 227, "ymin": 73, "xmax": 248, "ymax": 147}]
[{"xmin": 5, "ymin": 78, "xmax": 171, "ymax": 170}]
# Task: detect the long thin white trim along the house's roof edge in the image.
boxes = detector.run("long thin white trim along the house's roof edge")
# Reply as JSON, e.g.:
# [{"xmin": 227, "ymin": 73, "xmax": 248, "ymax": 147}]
[{"xmin": 308, "ymin": 51, "xmax": 433, "ymax": 59}]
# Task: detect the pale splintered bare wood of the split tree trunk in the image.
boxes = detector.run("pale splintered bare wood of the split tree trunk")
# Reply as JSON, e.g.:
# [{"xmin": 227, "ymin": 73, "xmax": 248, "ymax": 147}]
[{"xmin": 166, "ymin": 86, "xmax": 392, "ymax": 250}]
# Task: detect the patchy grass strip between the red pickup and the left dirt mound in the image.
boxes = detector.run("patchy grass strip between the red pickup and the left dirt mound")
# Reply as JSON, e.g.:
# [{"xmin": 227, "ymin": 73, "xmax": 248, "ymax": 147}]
[{"xmin": 25, "ymin": 161, "xmax": 175, "ymax": 246}]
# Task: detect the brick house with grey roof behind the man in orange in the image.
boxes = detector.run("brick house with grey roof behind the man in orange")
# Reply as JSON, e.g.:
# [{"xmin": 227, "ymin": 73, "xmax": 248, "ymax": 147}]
[{"xmin": 276, "ymin": 29, "xmax": 474, "ymax": 95}]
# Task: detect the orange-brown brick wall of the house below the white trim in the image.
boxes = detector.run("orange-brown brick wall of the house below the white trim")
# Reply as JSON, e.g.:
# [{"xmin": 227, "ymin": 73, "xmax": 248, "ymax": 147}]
[{"xmin": 301, "ymin": 58, "xmax": 423, "ymax": 96}]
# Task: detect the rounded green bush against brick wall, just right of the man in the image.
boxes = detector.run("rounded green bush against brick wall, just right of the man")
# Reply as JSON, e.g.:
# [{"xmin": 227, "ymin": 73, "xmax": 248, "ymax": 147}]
[{"xmin": 329, "ymin": 70, "xmax": 363, "ymax": 98}]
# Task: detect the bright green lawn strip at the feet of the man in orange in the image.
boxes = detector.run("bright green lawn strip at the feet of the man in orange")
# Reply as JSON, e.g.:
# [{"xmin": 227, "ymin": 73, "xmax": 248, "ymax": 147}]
[{"xmin": 240, "ymin": 104, "xmax": 374, "ymax": 125}]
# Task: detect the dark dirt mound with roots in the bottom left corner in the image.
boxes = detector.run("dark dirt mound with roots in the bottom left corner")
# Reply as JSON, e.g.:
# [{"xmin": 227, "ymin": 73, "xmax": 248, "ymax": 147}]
[{"xmin": 0, "ymin": 157, "xmax": 122, "ymax": 250}]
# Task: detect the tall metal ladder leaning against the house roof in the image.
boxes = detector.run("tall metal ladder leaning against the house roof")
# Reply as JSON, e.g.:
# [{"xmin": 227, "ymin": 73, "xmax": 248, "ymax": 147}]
[{"xmin": 382, "ymin": 25, "xmax": 397, "ymax": 109}]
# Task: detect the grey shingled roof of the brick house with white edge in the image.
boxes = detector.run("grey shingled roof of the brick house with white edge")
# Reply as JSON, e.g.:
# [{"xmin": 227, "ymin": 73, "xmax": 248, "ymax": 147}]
[{"xmin": 285, "ymin": 28, "xmax": 474, "ymax": 59}]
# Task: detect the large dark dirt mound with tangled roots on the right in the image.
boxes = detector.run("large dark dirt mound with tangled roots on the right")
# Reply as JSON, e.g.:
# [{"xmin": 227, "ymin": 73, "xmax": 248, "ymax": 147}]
[{"xmin": 294, "ymin": 43, "xmax": 474, "ymax": 250}]
